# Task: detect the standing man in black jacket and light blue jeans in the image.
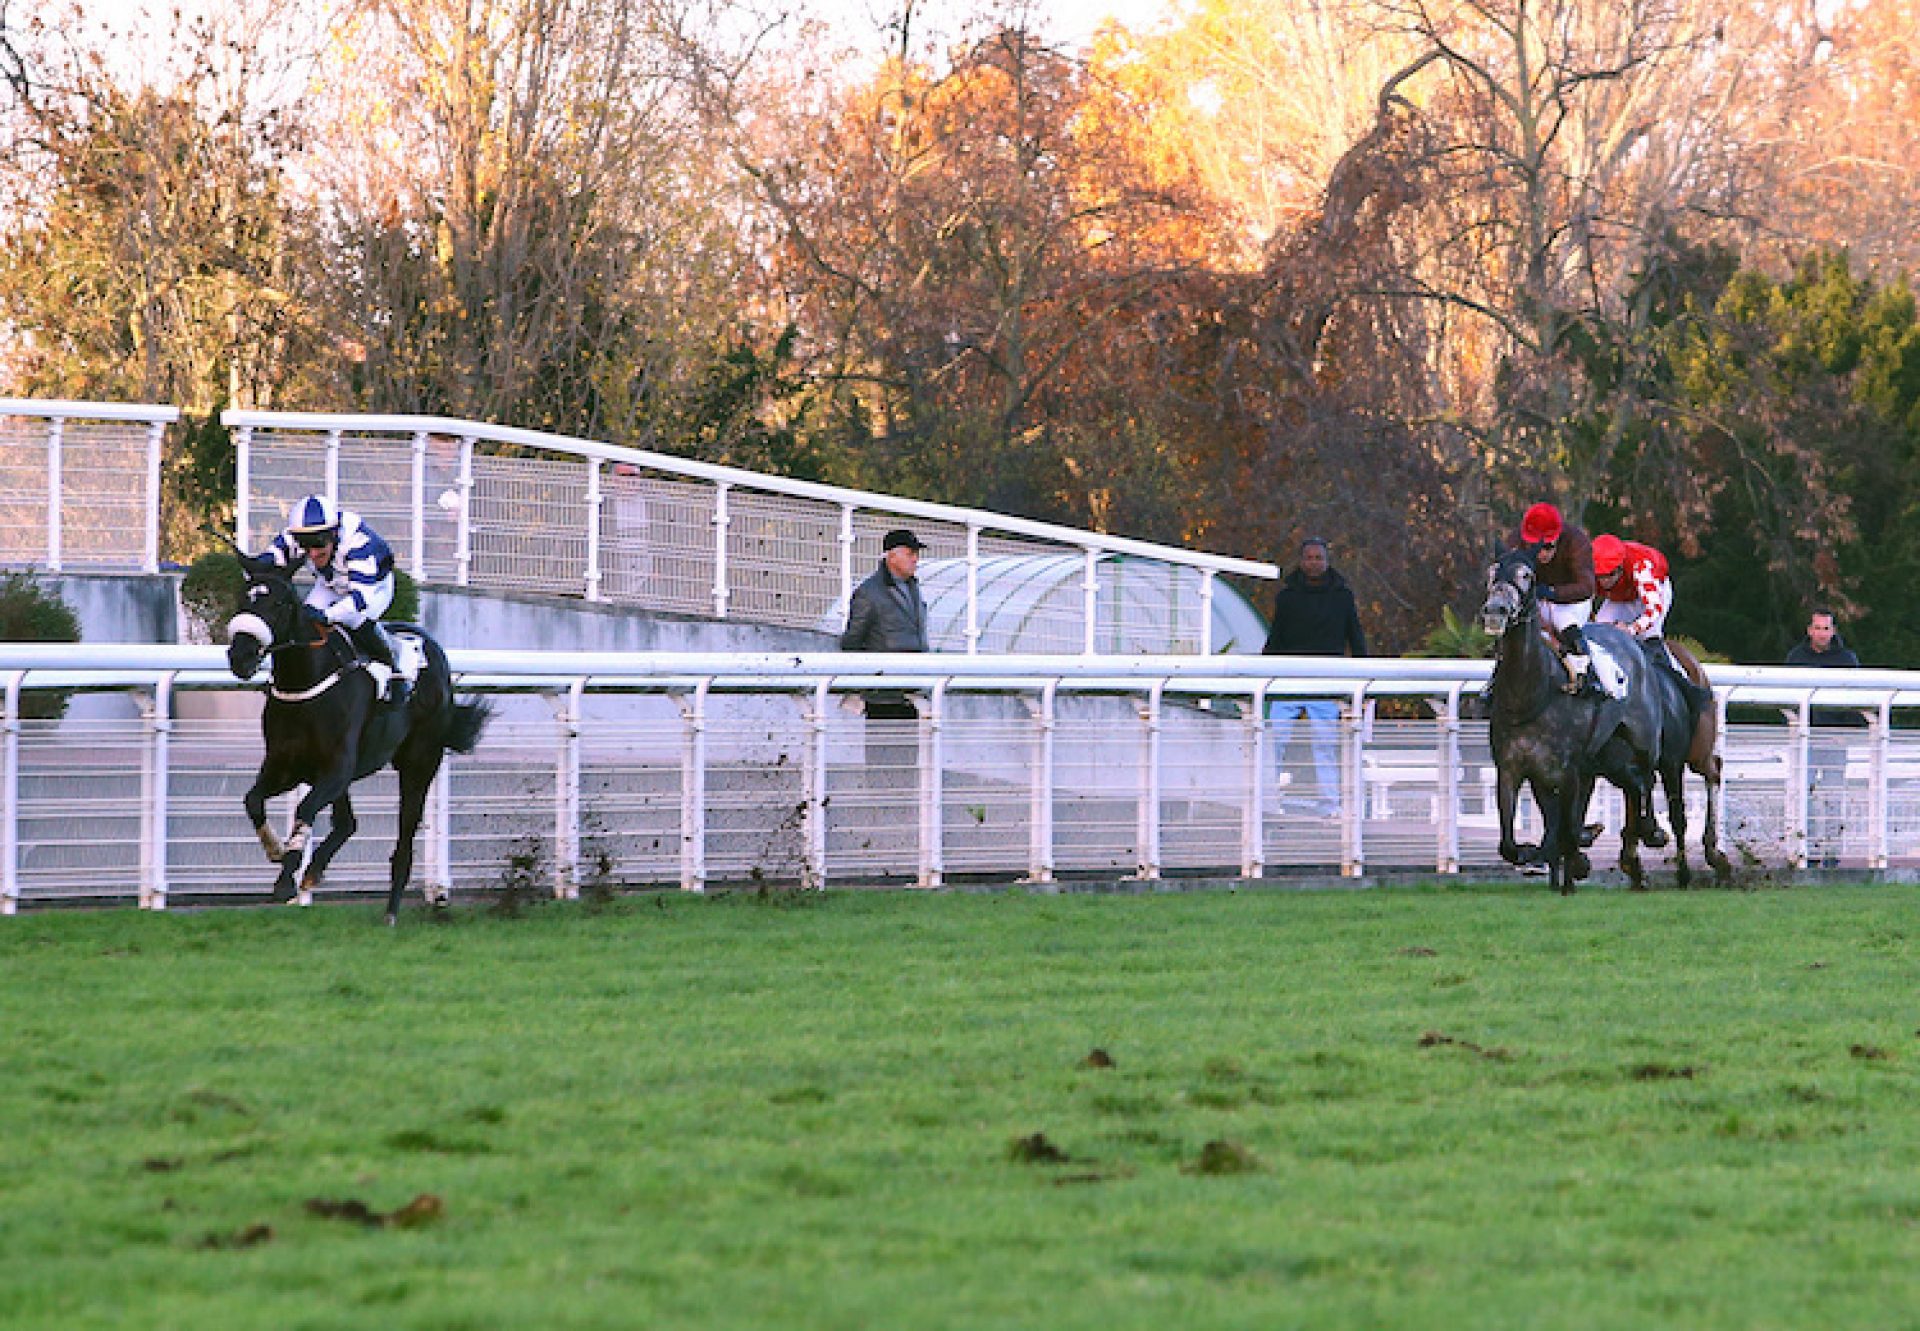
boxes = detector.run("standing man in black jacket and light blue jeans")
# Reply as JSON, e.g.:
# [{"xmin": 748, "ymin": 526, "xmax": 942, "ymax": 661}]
[{"xmin": 1263, "ymin": 536, "xmax": 1367, "ymax": 818}]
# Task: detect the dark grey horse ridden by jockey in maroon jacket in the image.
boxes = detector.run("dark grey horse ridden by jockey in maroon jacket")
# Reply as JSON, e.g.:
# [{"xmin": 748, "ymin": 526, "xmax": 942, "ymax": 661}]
[{"xmin": 1480, "ymin": 547, "xmax": 1661, "ymax": 893}]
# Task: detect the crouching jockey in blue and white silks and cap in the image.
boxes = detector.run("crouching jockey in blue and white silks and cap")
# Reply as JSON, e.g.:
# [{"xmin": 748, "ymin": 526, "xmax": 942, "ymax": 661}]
[{"xmin": 261, "ymin": 494, "xmax": 413, "ymax": 703}]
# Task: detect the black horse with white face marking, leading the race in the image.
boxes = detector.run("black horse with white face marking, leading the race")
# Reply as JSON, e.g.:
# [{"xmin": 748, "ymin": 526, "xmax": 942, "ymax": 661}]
[{"xmin": 227, "ymin": 555, "xmax": 490, "ymax": 924}]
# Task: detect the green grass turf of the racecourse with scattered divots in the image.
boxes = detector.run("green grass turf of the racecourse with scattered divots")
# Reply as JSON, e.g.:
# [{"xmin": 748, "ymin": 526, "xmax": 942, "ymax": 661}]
[{"xmin": 0, "ymin": 885, "xmax": 1920, "ymax": 1331}]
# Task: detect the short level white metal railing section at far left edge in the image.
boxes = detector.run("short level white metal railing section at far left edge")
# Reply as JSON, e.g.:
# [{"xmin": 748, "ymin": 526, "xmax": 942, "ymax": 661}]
[{"xmin": 0, "ymin": 398, "xmax": 180, "ymax": 572}]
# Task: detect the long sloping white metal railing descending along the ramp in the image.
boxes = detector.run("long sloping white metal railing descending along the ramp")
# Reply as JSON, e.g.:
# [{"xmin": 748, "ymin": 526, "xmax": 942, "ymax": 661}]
[{"xmin": 221, "ymin": 411, "xmax": 1281, "ymax": 655}]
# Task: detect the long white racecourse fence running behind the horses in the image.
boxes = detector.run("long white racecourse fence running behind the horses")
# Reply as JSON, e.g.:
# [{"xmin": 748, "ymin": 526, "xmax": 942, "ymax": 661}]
[{"xmin": 0, "ymin": 643, "xmax": 1920, "ymax": 912}]
